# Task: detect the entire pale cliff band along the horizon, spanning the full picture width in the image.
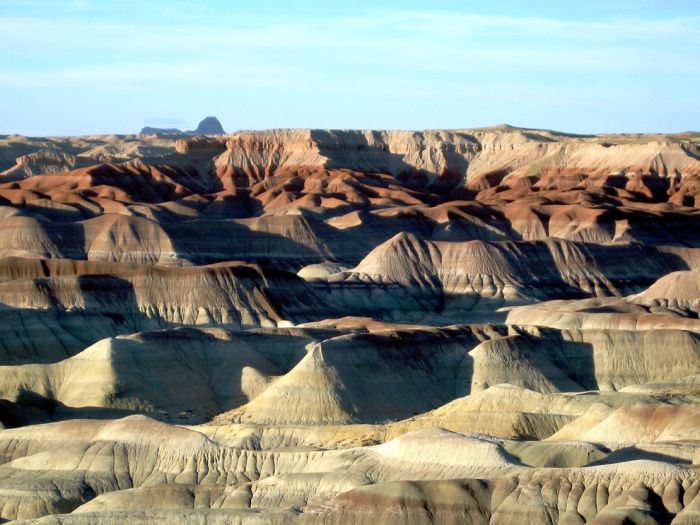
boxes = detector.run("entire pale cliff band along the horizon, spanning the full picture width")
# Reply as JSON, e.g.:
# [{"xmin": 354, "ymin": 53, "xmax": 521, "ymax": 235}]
[{"xmin": 0, "ymin": 126, "xmax": 700, "ymax": 192}]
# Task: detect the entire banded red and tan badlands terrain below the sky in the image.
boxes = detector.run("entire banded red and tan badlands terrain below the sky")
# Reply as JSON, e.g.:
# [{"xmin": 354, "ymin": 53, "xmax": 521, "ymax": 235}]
[{"xmin": 0, "ymin": 126, "xmax": 700, "ymax": 525}]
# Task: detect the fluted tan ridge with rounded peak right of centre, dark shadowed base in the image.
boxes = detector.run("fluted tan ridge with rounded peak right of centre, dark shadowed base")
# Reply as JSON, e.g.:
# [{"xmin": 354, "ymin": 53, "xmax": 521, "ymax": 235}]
[{"xmin": 322, "ymin": 233, "xmax": 696, "ymax": 327}]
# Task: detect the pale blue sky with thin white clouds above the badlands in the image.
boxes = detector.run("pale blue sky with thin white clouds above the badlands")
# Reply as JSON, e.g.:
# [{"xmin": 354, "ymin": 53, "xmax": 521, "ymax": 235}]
[{"xmin": 0, "ymin": 0, "xmax": 700, "ymax": 136}]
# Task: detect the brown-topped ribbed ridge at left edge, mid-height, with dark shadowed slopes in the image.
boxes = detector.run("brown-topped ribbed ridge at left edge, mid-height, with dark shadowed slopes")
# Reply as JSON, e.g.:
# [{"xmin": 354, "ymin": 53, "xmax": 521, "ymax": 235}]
[{"xmin": 0, "ymin": 260, "xmax": 331, "ymax": 363}]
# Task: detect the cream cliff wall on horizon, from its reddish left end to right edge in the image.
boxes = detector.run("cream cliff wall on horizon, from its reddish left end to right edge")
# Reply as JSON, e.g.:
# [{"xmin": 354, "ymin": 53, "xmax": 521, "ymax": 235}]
[{"xmin": 216, "ymin": 128, "xmax": 700, "ymax": 191}]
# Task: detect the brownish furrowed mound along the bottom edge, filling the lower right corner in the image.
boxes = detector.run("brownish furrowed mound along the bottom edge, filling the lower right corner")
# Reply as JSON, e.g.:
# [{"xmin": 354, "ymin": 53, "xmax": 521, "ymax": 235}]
[{"xmin": 302, "ymin": 462, "xmax": 698, "ymax": 525}]
